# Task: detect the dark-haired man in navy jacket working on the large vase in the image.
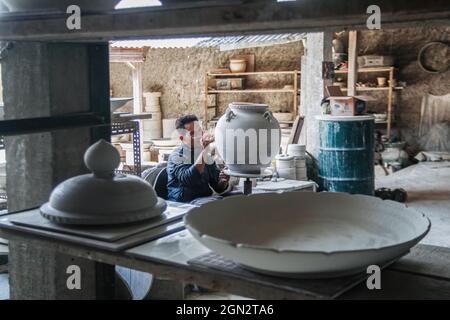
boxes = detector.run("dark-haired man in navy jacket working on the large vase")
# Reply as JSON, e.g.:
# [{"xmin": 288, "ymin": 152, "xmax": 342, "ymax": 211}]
[{"xmin": 167, "ymin": 115, "xmax": 229, "ymax": 203}]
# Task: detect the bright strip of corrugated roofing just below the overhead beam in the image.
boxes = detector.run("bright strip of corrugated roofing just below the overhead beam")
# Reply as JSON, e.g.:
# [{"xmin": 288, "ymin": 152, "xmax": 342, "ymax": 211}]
[{"xmin": 111, "ymin": 33, "xmax": 305, "ymax": 50}]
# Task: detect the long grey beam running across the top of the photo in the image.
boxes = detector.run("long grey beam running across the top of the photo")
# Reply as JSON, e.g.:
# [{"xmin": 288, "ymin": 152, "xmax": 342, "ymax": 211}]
[{"xmin": 0, "ymin": 0, "xmax": 450, "ymax": 41}]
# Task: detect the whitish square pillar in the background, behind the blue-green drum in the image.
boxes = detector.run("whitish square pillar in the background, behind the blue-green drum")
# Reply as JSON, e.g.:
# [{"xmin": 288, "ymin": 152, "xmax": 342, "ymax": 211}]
[{"xmin": 300, "ymin": 32, "xmax": 333, "ymax": 159}]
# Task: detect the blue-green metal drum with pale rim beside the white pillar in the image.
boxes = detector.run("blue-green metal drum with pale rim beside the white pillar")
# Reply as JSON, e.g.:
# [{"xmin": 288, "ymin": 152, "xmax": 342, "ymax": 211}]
[{"xmin": 317, "ymin": 116, "xmax": 375, "ymax": 195}]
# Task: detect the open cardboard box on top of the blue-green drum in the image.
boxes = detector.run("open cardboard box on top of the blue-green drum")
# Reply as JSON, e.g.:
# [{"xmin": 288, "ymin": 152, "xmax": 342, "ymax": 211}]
[{"xmin": 327, "ymin": 86, "xmax": 374, "ymax": 116}]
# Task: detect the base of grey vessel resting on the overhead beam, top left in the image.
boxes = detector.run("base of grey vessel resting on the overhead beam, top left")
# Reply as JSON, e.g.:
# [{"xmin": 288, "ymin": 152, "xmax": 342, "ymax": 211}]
[{"xmin": 2, "ymin": 0, "xmax": 120, "ymax": 12}]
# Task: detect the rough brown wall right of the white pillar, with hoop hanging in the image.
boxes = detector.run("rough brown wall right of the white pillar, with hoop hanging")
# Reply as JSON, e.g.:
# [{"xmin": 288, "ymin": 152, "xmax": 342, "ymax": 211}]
[{"xmin": 341, "ymin": 27, "xmax": 450, "ymax": 151}]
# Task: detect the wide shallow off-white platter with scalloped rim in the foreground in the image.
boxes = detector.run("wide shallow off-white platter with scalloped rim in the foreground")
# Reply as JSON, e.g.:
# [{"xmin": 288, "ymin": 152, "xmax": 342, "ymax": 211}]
[{"xmin": 184, "ymin": 192, "xmax": 431, "ymax": 278}]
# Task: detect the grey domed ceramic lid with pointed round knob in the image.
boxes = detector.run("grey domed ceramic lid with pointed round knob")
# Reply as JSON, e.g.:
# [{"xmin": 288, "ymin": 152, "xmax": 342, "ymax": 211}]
[{"xmin": 40, "ymin": 140, "xmax": 167, "ymax": 225}]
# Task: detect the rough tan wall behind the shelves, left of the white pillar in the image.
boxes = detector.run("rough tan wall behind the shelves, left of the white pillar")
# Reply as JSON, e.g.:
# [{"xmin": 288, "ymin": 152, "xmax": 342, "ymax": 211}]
[{"xmin": 111, "ymin": 42, "xmax": 303, "ymax": 118}]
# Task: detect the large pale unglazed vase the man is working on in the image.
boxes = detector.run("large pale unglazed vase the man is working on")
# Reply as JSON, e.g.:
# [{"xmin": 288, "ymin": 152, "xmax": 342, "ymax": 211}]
[{"xmin": 215, "ymin": 102, "xmax": 281, "ymax": 175}]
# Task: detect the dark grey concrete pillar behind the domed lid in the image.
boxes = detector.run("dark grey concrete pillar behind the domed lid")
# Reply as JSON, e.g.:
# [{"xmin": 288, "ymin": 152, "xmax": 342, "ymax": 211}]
[{"xmin": 2, "ymin": 42, "xmax": 96, "ymax": 211}]
